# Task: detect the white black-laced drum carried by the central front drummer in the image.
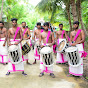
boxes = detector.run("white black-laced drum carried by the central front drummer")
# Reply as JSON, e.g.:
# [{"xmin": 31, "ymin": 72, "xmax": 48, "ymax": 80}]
[{"xmin": 40, "ymin": 46, "xmax": 54, "ymax": 67}]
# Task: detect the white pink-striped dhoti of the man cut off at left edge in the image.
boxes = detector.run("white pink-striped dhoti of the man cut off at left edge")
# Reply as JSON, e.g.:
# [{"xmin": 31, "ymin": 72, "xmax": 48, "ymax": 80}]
[{"xmin": 0, "ymin": 38, "xmax": 8, "ymax": 63}]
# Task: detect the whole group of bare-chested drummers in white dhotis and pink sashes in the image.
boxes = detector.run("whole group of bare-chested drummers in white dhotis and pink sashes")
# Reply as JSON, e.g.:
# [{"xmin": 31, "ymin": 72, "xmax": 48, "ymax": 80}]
[{"xmin": 0, "ymin": 18, "xmax": 87, "ymax": 78}]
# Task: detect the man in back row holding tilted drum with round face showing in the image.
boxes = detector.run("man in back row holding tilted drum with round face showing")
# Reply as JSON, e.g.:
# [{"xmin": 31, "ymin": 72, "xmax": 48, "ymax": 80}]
[{"xmin": 56, "ymin": 24, "xmax": 68, "ymax": 64}]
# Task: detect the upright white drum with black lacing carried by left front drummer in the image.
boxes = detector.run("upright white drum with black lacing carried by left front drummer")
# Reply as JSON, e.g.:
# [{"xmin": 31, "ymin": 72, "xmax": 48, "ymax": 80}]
[{"xmin": 8, "ymin": 45, "xmax": 22, "ymax": 64}]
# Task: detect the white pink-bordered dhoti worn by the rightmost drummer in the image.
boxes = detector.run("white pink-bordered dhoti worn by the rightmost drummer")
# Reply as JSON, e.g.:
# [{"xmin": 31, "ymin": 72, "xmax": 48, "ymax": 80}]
[{"xmin": 69, "ymin": 44, "xmax": 84, "ymax": 76}]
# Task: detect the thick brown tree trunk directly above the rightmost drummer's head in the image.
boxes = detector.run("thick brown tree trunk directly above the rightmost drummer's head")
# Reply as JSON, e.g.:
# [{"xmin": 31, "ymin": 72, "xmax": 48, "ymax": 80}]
[{"xmin": 70, "ymin": 0, "xmax": 78, "ymax": 21}]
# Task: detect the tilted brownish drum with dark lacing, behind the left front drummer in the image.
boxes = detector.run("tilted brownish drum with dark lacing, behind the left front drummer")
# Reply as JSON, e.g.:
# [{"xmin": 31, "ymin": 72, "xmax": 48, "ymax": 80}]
[{"xmin": 22, "ymin": 40, "xmax": 31, "ymax": 55}]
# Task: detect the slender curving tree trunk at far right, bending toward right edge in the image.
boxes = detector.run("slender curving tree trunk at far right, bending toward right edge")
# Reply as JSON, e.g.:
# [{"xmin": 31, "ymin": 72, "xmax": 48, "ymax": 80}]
[{"xmin": 77, "ymin": 0, "xmax": 88, "ymax": 35}]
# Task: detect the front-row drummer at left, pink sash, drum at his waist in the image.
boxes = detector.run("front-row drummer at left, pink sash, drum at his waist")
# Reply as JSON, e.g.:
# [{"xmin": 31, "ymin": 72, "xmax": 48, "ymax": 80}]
[{"xmin": 6, "ymin": 18, "xmax": 27, "ymax": 75}]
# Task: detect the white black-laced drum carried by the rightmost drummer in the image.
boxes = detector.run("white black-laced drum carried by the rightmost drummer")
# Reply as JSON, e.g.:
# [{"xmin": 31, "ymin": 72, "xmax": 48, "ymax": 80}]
[{"xmin": 65, "ymin": 47, "xmax": 82, "ymax": 67}]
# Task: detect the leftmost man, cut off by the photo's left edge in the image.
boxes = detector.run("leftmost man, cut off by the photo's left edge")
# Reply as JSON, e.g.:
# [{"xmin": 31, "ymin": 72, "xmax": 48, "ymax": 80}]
[{"xmin": 0, "ymin": 21, "xmax": 8, "ymax": 65}]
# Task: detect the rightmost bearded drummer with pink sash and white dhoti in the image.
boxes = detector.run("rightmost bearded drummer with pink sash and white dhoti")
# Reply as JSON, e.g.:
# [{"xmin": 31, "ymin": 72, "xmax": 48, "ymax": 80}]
[{"xmin": 69, "ymin": 21, "xmax": 86, "ymax": 76}]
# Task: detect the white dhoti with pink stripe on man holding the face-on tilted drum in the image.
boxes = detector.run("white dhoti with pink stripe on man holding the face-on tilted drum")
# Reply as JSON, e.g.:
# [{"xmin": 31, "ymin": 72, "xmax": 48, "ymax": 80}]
[{"xmin": 56, "ymin": 39, "xmax": 68, "ymax": 63}]
